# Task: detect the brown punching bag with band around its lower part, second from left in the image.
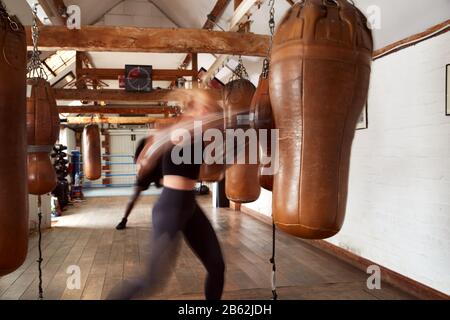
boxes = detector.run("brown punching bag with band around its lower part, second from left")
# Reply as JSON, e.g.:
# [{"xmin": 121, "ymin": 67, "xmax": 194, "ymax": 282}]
[{"xmin": 27, "ymin": 78, "xmax": 59, "ymax": 195}]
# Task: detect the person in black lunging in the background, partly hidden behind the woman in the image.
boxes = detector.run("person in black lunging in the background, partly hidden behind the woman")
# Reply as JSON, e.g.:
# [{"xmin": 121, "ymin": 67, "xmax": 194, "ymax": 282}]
[{"xmin": 116, "ymin": 139, "xmax": 162, "ymax": 230}]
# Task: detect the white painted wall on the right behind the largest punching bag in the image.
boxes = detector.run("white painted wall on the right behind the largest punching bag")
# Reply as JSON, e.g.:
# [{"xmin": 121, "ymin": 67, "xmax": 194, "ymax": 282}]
[{"xmin": 247, "ymin": 33, "xmax": 450, "ymax": 294}]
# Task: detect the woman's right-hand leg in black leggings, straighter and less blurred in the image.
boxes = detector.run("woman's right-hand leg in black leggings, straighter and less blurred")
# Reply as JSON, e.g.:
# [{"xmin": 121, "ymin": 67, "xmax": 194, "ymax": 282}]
[{"xmin": 183, "ymin": 204, "xmax": 225, "ymax": 300}]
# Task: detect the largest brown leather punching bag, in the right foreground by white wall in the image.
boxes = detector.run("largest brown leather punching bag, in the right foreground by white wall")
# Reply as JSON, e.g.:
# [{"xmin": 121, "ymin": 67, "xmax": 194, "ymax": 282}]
[{"xmin": 270, "ymin": 0, "xmax": 373, "ymax": 239}]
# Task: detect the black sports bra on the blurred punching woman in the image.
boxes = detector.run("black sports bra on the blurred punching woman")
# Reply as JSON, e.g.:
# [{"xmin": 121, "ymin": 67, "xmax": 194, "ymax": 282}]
[{"xmin": 162, "ymin": 142, "xmax": 203, "ymax": 180}]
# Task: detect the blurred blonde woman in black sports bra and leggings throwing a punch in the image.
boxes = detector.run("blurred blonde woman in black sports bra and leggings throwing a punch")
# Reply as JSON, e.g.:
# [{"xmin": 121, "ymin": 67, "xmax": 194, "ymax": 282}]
[{"xmin": 109, "ymin": 93, "xmax": 225, "ymax": 300}]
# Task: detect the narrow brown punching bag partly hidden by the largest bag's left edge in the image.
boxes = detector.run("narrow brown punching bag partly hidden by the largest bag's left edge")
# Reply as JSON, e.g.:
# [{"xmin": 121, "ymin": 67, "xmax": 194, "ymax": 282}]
[{"xmin": 251, "ymin": 73, "xmax": 275, "ymax": 191}]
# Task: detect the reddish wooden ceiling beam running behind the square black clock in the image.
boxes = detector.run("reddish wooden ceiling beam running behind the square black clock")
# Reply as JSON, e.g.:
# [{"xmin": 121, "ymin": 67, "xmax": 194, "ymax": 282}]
[{"xmin": 79, "ymin": 69, "xmax": 197, "ymax": 81}]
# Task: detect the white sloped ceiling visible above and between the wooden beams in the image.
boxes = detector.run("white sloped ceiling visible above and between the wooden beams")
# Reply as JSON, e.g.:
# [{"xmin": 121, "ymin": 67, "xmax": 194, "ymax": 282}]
[{"xmin": 3, "ymin": 0, "xmax": 450, "ymax": 86}]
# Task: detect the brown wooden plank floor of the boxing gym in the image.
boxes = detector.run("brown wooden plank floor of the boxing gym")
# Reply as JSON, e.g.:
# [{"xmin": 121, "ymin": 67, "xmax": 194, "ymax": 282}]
[{"xmin": 0, "ymin": 196, "xmax": 412, "ymax": 300}]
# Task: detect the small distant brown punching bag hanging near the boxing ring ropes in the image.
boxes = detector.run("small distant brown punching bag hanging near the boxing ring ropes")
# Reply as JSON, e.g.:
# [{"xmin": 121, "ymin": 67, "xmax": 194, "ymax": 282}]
[{"xmin": 83, "ymin": 124, "xmax": 102, "ymax": 181}]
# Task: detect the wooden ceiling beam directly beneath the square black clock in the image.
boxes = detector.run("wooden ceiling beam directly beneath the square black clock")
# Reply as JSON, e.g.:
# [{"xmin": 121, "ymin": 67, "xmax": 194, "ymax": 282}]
[{"xmin": 53, "ymin": 89, "xmax": 222, "ymax": 102}]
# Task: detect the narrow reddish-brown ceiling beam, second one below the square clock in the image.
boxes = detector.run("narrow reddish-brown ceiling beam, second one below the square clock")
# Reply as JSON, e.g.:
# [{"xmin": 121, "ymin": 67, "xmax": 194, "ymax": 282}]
[{"xmin": 57, "ymin": 106, "xmax": 178, "ymax": 115}]
